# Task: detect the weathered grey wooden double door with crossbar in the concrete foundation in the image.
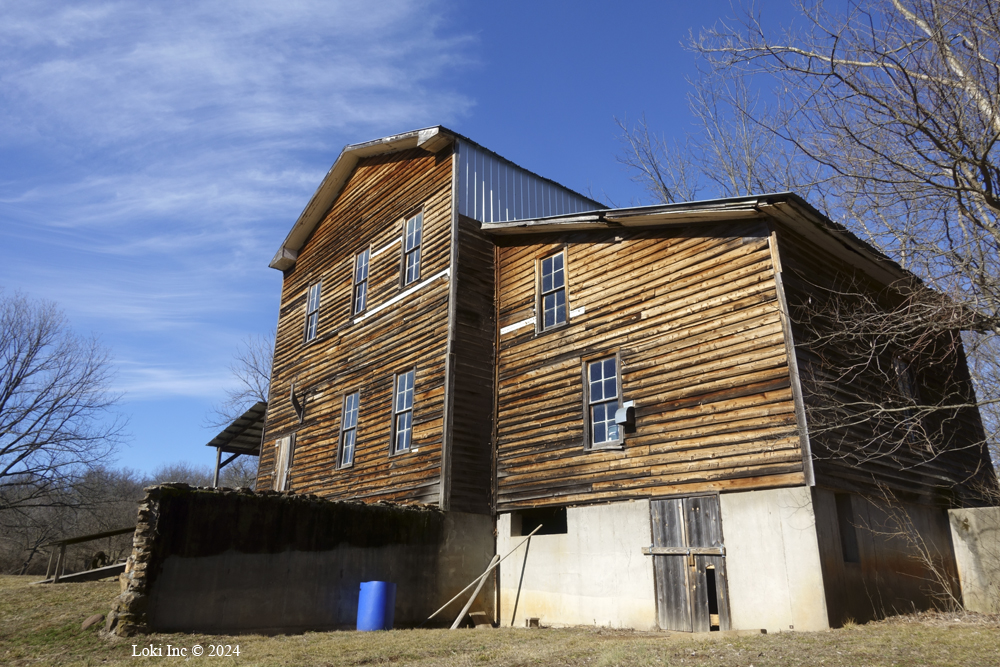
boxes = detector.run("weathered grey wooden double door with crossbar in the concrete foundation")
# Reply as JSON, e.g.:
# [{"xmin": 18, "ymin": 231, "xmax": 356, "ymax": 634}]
[{"xmin": 648, "ymin": 496, "xmax": 729, "ymax": 632}]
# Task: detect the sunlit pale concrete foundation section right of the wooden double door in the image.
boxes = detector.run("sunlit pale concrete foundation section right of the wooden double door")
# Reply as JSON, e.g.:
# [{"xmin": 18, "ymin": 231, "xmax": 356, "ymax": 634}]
[{"xmin": 719, "ymin": 487, "xmax": 829, "ymax": 632}]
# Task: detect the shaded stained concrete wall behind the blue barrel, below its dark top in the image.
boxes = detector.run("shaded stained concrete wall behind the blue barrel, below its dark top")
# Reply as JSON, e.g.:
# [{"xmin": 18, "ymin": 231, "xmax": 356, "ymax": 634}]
[{"xmin": 148, "ymin": 513, "xmax": 494, "ymax": 633}]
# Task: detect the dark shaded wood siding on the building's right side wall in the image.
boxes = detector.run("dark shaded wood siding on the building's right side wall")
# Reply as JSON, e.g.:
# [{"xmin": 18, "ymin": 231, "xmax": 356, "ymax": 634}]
[{"xmin": 776, "ymin": 226, "xmax": 996, "ymax": 506}]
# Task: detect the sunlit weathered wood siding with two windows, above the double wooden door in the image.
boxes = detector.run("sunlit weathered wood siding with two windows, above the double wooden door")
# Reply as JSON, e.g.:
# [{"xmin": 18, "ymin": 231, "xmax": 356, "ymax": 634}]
[{"xmin": 497, "ymin": 222, "xmax": 804, "ymax": 511}]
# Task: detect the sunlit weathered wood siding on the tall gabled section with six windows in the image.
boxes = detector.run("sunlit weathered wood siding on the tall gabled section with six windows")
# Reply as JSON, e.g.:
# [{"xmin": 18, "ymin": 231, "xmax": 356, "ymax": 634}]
[{"xmin": 258, "ymin": 149, "xmax": 452, "ymax": 503}]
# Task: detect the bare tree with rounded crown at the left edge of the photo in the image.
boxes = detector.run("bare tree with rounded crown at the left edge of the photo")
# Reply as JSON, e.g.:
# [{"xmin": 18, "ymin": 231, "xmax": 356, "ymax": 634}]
[{"xmin": 0, "ymin": 292, "xmax": 125, "ymax": 514}]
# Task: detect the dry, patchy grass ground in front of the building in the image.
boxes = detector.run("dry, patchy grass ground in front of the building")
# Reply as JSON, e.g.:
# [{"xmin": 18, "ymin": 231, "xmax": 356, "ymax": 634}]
[{"xmin": 0, "ymin": 576, "xmax": 1000, "ymax": 667}]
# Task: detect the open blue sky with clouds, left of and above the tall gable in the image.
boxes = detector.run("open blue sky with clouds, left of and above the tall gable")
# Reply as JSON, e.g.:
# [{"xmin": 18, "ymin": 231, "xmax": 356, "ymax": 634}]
[{"xmin": 0, "ymin": 0, "xmax": 785, "ymax": 471}]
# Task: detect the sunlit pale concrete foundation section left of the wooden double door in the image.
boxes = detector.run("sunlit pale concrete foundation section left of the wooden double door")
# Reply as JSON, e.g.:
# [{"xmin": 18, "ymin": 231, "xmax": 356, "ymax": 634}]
[{"xmin": 497, "ymin": 500, "xmax": 657, "ymax": 630}]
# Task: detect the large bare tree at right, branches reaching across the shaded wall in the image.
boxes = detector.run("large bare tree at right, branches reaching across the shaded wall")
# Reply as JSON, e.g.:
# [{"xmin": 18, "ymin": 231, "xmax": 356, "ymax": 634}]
[{"xmin": 623, "ymin": 0, "xmax": 1000, "ymax": 480}]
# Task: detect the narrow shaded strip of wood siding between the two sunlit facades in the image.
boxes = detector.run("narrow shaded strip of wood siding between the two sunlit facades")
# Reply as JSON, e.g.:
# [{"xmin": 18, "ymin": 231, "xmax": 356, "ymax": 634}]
[{"xmin": 447, "ymin": 216, "xmax": 496, "ymax": 514}]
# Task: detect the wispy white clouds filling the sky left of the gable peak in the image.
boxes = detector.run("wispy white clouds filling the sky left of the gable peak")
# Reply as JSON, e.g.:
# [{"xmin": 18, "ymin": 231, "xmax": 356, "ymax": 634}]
[{"xmin": 0, "ymin": 0, "xmax": 473, "ymax": 412}]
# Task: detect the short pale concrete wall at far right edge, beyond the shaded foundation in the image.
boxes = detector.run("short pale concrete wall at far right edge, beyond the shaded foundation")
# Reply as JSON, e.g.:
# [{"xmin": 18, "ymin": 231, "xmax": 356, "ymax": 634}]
[{"xmin": 948, "ymin": 507, "xmax": 1000, "ymax": 614}]
